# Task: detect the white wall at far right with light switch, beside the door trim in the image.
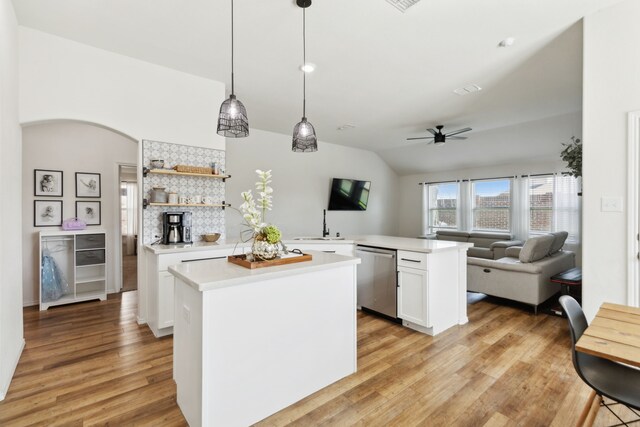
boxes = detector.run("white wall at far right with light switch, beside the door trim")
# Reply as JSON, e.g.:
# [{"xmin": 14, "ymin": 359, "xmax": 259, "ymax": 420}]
[{"xmin": 583, "ymin": 0, "xmax": 640, "ymax": 318}]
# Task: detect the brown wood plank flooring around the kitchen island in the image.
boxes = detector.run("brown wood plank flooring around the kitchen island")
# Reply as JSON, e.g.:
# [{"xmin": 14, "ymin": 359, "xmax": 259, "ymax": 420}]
[{"xmin": 0, "ymin": 292, "xmax": 628, "ymax": 426}]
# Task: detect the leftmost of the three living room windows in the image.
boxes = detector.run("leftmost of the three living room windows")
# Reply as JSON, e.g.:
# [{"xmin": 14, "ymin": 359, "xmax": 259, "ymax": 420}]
[{"xmin": 427, "ymin": 182, "xmax": 458, "ymax": 234}]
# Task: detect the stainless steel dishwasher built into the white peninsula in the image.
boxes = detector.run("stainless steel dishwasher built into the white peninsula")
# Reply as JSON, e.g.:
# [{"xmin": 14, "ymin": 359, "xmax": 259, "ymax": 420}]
[{"xmin": 356, "ymin": 245, "xmax": 397, "ymax": 319}]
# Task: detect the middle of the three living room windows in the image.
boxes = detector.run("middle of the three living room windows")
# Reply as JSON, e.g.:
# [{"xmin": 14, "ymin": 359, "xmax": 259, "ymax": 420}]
[{"xmin": 471, "ymin": 179, "xmax": 511, "ymax": 231}]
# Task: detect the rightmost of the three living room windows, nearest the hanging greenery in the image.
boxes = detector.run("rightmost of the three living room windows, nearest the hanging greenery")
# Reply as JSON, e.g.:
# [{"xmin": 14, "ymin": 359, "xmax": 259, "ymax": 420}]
[{"xmin": 529, "ymin": 175, "xmax": 554, "ymax": 234}]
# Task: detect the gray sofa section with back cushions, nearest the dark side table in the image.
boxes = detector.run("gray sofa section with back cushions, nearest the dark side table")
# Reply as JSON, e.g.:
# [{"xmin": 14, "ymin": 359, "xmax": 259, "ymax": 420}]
[{"xmin": 467, "ymin": 231, "xmax": 575, "ymax": 312}]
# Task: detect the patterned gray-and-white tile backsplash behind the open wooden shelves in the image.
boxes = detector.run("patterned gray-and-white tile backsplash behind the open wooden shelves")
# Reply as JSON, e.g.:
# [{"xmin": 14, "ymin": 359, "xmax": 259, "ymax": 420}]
[{"xmin": 142, "ymin": 140, "xmax": 225, "ymax": 244}]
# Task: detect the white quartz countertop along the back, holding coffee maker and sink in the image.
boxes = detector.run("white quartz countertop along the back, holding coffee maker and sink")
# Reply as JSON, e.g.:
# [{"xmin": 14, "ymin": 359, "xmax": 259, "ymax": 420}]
[{"xmin": 145, "ymin": 235, "xmax": 473, "ymax": 255}]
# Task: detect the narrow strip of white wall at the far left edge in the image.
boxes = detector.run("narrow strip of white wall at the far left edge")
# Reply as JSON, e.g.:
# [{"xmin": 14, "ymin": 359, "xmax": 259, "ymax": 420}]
[{"xmin": 0, "ymin": 0, "xmax": 24, "ymax": 400}]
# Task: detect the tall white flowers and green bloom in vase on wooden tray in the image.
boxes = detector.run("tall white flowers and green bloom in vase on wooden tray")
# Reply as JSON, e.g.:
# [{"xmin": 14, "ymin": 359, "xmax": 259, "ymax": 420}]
[{"xmin": 239, "ymin": 169, "xmax": 287, "ymax": 261}]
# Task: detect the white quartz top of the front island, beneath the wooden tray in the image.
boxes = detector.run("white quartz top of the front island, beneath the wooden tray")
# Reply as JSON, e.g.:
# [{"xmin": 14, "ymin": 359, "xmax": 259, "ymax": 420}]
[{"xmin": 169, "ymin": 251, "xmax": 360, "ymax": 292}]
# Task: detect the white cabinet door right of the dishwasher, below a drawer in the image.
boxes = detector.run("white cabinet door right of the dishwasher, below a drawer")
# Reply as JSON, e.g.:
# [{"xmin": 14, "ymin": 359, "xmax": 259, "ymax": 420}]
[{"xmin": 398, "ymin": 266, "xmax": 431, "ymax": 328}]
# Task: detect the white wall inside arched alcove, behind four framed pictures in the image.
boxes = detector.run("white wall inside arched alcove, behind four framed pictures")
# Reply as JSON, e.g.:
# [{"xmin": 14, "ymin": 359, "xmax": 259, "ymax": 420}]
[{"xmin": 22, "ymin": 121, "xmax": 138, "ymax": 305}]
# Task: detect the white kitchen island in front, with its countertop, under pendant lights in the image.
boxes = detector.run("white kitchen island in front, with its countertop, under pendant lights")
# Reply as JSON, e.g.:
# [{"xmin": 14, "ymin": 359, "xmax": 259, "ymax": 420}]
[{"xmin": 169, "ymin": 252, "xmax": 360, "ymax": 426}]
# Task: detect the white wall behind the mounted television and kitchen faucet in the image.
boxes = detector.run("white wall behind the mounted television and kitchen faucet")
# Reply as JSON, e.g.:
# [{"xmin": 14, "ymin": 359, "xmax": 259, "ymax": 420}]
[{"xmin": 226, "ymin": 129, "xmax": 398, "ymax": 239}]
